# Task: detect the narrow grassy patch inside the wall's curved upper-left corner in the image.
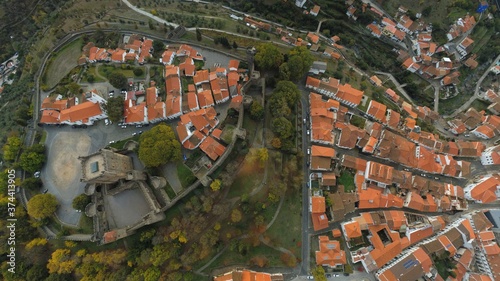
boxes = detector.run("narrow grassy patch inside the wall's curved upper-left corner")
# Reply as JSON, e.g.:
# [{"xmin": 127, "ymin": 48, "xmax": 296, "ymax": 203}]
[{"xmin": 44, "ymin": 38, "xmax": 83, "ymax": 88}]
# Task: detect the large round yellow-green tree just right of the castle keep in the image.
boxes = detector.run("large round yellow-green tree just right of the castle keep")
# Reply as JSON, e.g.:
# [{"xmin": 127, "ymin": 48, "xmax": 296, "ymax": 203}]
[{"xmin": 139, "ymin": 123, "xmax": 181, "ymax": 167}]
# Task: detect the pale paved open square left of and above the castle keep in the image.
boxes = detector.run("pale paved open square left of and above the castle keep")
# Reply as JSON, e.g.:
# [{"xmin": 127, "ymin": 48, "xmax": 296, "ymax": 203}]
[{"xmin": 41, "ymin": 121, "xmax": 151, "ymax": 224}]
